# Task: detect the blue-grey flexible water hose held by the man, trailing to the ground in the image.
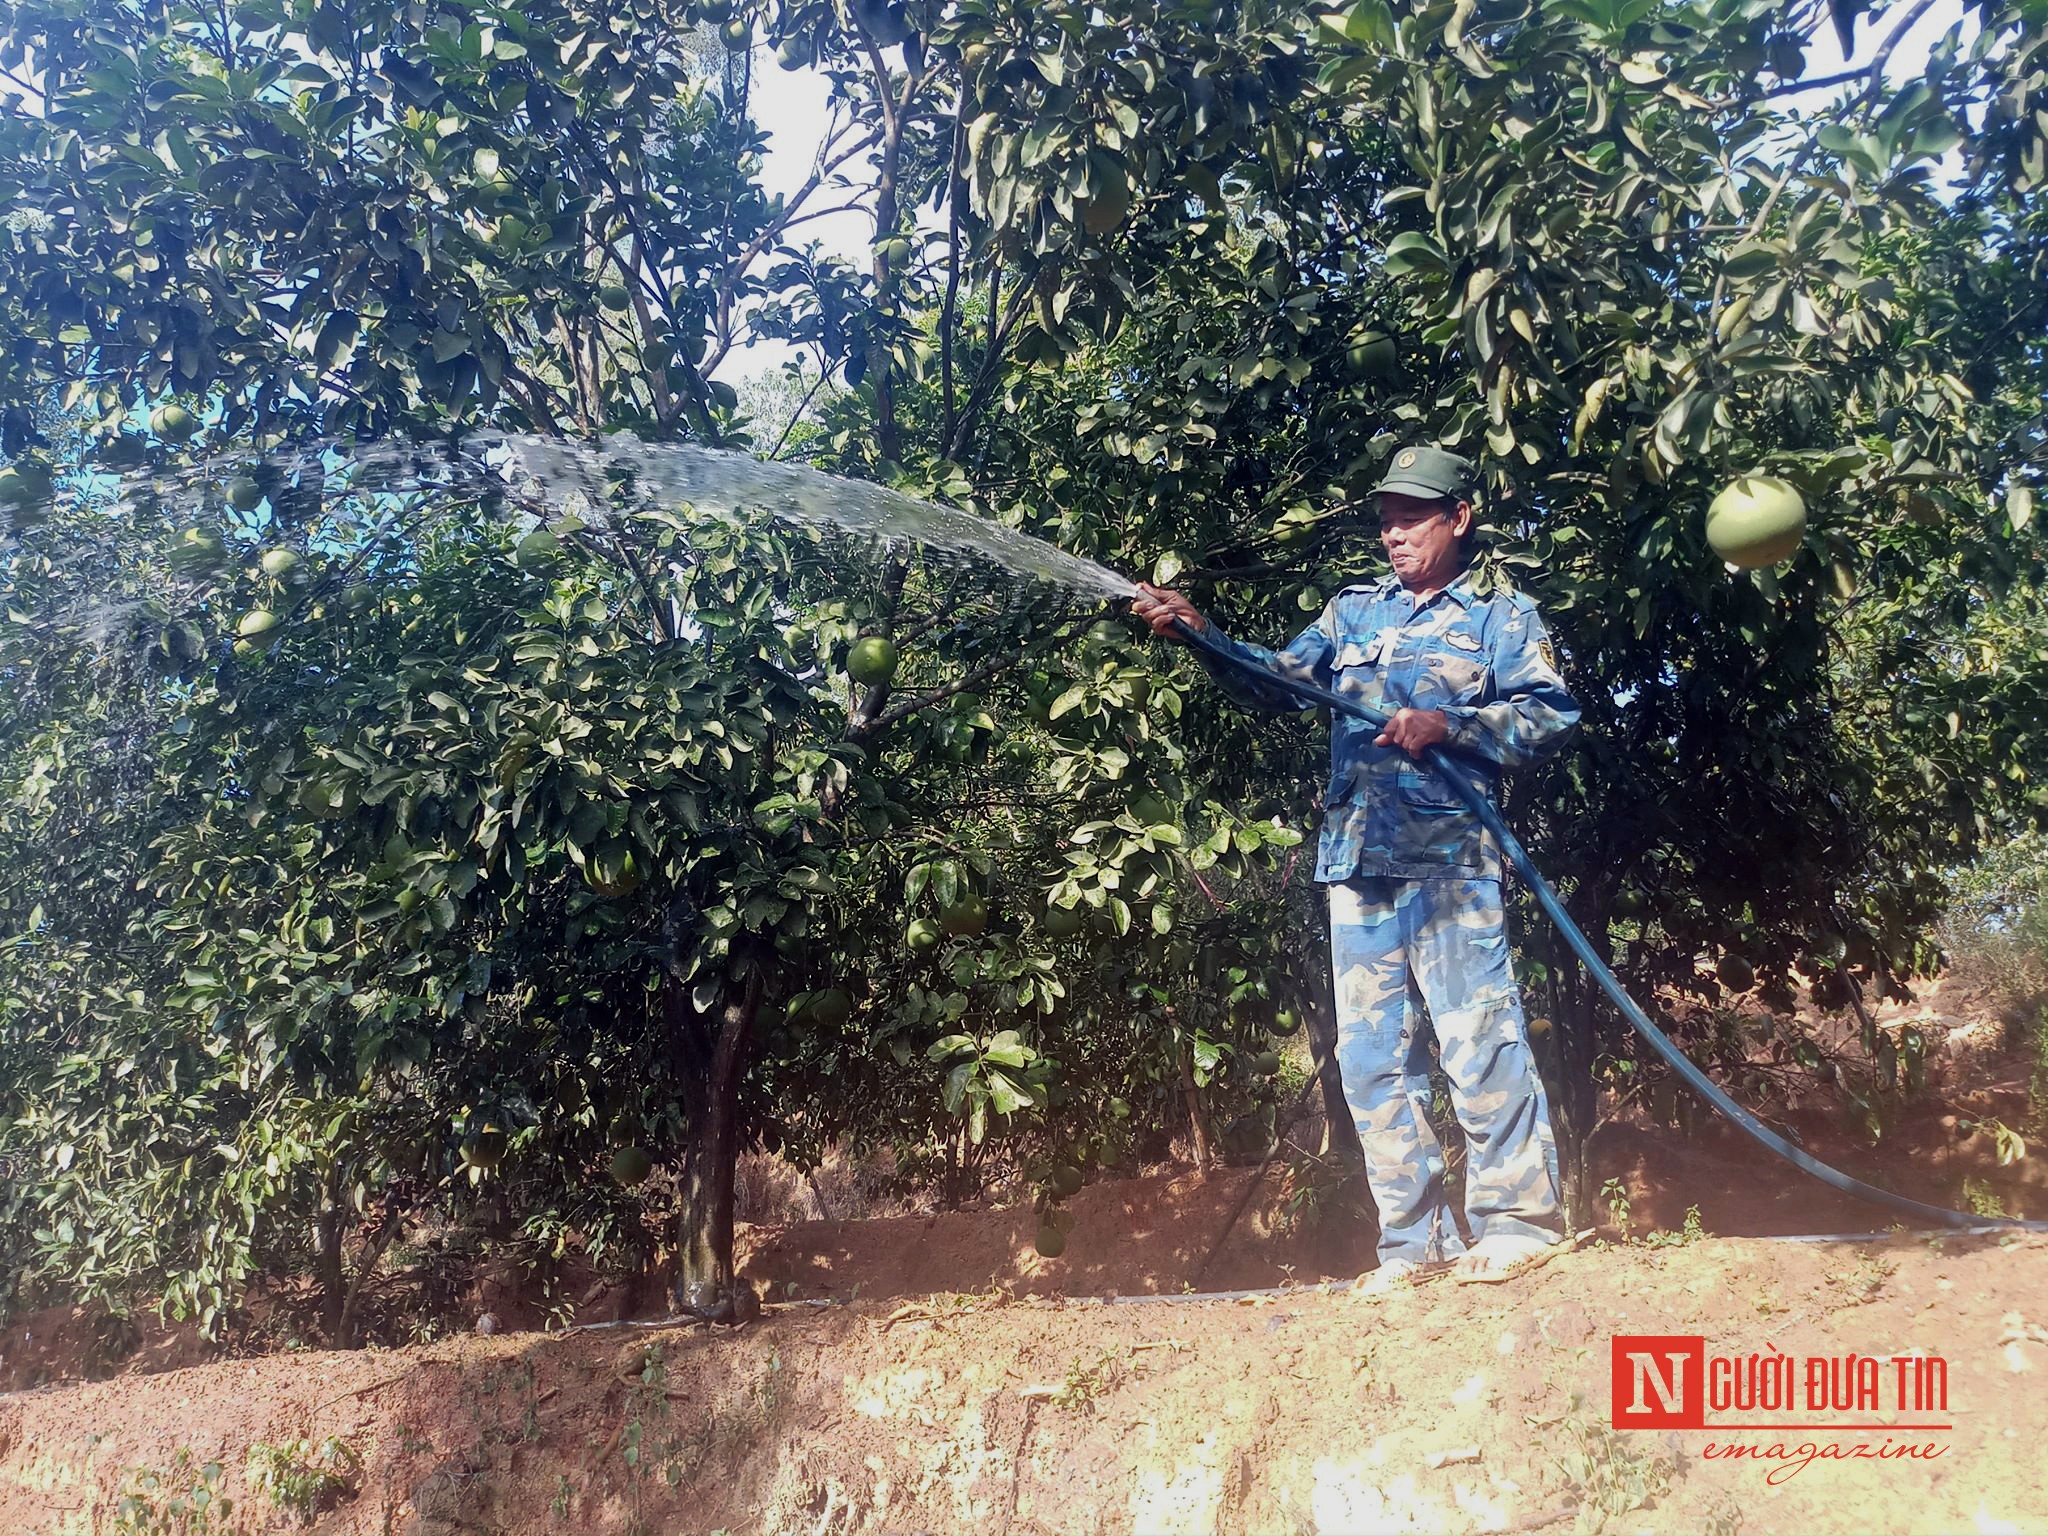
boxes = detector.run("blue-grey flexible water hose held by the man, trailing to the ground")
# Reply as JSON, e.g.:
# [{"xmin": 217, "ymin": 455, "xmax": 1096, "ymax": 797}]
[{"xmin": 1174, "ymin": 621, "xmax": 2048, "ymax": 1231}]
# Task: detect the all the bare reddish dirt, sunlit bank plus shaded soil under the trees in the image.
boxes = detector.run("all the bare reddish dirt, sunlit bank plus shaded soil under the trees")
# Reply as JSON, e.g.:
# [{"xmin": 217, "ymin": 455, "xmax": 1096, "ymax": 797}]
[{"xmin": 0, "ymin": 989, "xmax": 2048, "ymax": 1536}]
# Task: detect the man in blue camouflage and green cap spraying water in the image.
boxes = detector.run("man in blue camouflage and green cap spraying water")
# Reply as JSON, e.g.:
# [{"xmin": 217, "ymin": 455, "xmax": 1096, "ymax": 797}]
[{"xmin": 1133, "ymin": 446, "xmax": 1579, "ymax": 1284}]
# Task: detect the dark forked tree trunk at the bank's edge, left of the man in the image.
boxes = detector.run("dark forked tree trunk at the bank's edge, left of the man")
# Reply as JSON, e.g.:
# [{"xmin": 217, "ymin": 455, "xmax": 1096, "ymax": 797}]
[{"xmin": 668, "ymin": 950, "xmax": 762, "ymax": 1315}]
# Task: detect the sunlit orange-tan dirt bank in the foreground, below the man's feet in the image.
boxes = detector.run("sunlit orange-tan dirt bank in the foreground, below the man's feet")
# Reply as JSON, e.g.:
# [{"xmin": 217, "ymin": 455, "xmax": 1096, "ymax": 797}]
[{"xmin": 0, "ymin": 1212, "xmax": 2048, "ymax": 1536}]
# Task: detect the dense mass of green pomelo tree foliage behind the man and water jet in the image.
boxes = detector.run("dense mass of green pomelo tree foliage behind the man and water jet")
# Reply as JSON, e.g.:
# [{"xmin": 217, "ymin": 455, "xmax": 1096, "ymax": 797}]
[{"xmin": 0, "ymin": 0, "xmax": 2048, "ymax": 1333}]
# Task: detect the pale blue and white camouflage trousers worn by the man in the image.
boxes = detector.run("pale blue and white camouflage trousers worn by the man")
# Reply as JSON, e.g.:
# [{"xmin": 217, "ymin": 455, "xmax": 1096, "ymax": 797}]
[{"xmin": 1329, "ymin": 877, "xmax": 1563, "ymax": 1262}]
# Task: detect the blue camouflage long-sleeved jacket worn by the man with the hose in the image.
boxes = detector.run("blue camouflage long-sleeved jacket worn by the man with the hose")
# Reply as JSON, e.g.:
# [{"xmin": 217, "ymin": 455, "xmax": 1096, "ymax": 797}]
[{"xmin": 1198, "ymin": 573, "xmax": 1579, "ymax": 883}]
